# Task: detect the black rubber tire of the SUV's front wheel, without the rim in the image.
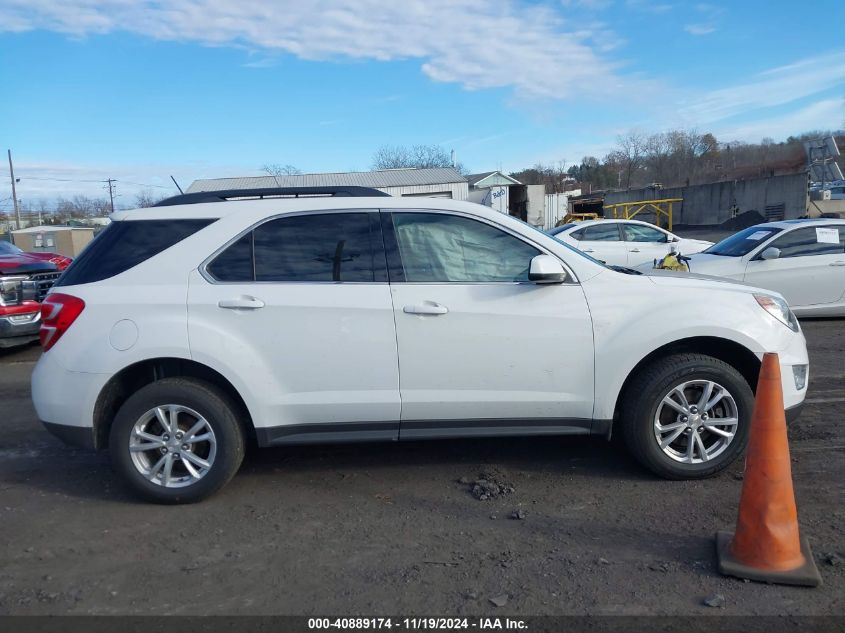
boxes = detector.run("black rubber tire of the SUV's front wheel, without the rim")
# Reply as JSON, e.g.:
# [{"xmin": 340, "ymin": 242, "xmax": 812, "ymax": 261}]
[{"xmin": 620, "ymin": 353, "xmax": 754, "ymax": 479}]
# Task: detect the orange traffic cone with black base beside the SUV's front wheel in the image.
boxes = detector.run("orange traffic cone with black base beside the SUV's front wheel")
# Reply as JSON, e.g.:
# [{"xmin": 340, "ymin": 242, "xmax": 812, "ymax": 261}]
[{"xmin": 716, "ymin": 354, "xmax": 822, "ymax": 587}]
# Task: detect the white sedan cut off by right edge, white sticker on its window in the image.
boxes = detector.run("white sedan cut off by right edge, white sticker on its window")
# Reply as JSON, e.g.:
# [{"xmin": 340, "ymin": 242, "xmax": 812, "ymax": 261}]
[{"xmin": 689, "ymin": 218, "xmax": 845, "ymax": 317}]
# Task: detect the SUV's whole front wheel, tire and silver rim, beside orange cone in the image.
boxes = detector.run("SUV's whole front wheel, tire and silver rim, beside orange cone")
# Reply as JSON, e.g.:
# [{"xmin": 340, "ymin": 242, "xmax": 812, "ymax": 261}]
[{"xmin": 621, "ymin": 354, "xmax": 754, "ymax": 479}]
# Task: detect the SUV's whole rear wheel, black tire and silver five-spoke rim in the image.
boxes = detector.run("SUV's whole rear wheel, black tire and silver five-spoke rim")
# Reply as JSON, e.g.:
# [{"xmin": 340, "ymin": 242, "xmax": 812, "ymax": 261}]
[{"xmin": 109, "ymin": 378, "xmax": 244, "ymax": 503}]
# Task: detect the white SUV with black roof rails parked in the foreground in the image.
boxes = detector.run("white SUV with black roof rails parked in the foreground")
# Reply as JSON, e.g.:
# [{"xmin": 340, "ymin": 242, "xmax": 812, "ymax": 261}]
[{"xmin": 32, "ymin": 188, "xmax": 808, "ymax": 503}]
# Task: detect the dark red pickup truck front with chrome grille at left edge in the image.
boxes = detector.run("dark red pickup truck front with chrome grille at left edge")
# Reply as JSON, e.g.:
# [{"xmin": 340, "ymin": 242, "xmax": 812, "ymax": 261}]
[{"xmin": 0, "ymin": 241, "xmax": 71, "ymax": 348}]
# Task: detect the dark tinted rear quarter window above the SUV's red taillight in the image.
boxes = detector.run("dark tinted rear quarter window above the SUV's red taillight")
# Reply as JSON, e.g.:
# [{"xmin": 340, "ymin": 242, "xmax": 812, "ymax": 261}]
[{"xmin": 55, "ymin": 219, "xmax": 214, "ymax": 286}]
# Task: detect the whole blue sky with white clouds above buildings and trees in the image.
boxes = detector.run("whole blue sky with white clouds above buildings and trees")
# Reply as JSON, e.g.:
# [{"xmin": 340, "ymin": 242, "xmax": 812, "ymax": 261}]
[{"xmin": 0, "ymin": 0, "xmax": 845, "ymax": 209}]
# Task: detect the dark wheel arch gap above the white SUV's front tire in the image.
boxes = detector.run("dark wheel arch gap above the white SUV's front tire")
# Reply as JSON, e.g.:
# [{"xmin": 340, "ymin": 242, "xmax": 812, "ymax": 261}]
[{"xmin": 608, "ymin": 336, "xmax": 760, "ymax": 438}]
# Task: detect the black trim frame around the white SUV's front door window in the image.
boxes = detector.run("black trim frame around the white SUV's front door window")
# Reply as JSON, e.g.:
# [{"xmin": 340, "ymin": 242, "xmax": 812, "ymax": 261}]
[{"xmin": 381, "ymin": 208, "xmax": 579, "ymax": 286}]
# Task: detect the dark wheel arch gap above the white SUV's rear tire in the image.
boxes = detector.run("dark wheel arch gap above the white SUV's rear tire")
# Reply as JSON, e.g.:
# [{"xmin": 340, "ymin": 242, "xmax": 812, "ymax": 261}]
[{"xmin": 92, "ymin": 357, "xmax": 255, "ymax": 449}]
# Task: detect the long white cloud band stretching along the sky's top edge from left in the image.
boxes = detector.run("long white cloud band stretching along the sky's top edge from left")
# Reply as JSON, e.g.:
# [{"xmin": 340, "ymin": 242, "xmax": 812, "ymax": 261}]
[{"xmin": 0, "ymin": 0, "xmax": 640, "ymax": 99}]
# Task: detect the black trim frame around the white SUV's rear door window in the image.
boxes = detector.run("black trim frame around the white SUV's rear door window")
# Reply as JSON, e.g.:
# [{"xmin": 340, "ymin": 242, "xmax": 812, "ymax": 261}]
[{"xmin": 198, "ymin": 208, "xmax": 388, "ymax": 286}]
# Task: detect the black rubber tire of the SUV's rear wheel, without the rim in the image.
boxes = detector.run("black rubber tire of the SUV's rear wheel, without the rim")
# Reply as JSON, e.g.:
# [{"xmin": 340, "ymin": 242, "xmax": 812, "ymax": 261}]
[{"xmin": 109, "ymin": 378, "xmax": 244, "ymax": 504}]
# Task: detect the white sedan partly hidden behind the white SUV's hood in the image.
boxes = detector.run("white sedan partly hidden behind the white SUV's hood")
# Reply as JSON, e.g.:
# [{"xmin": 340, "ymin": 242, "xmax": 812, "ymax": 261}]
[{"xmin": 549, "ymin": 220, "xmax": 713, "ymax": 268}]
